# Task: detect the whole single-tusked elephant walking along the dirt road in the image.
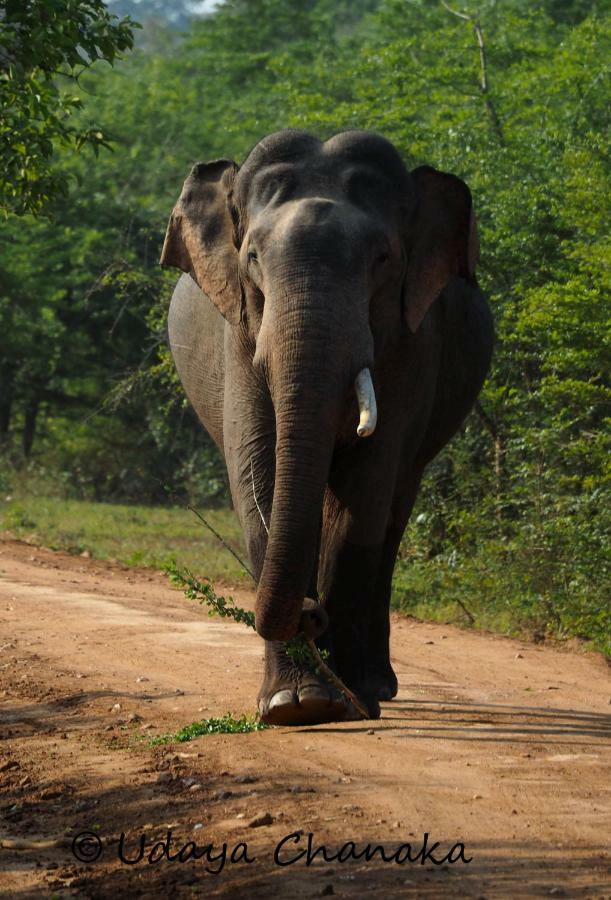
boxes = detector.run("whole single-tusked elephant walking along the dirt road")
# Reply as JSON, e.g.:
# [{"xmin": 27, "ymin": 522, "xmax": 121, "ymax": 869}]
[{"xmin": 160, "ymin": 129, "xmax": 493, "ymax": 725}]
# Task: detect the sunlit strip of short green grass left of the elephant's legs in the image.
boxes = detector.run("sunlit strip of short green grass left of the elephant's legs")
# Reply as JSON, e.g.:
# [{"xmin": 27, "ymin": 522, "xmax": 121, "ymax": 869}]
[{"xmin": 0, "ymin": 495, "xmax": 250, "ymax": 584}]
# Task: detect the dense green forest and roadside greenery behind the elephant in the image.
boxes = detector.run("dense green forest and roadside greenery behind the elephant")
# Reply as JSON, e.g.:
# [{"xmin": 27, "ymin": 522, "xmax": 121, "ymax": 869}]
[{"xmin": 0, "ymin": 0, "xmax": 611, "ymax": 651}]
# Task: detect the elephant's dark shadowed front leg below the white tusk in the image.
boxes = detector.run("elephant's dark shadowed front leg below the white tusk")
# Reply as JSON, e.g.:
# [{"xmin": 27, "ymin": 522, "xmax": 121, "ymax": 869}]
[{"xmin": 319, "ymin": 376, "xmax": 440, "ymax": 716}]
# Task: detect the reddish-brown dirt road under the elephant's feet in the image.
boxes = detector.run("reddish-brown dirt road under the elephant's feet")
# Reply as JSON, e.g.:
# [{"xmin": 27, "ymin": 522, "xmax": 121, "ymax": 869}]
[{"xmin": 0, "ymin": 541, "xmax": 611, "ymax": 898}]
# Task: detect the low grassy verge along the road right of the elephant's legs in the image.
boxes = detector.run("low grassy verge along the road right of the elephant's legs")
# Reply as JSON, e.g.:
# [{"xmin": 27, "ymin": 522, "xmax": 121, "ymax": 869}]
[{"xmin": 391, "ymin": 540, "xmax": 611, "ymax": 655}]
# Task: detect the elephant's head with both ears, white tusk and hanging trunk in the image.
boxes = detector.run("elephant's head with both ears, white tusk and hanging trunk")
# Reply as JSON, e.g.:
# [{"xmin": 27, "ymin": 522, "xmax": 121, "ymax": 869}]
[{"xmin": 161, "ymin": 131, "xmax": 477, "ymax": 640}]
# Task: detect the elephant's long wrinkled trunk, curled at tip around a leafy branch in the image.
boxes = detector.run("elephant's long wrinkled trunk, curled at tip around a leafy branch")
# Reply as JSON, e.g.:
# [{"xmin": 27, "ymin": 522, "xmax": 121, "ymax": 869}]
[{"xmin": 256, "ymin": 295, "xmax": 371, "ymax": 640}]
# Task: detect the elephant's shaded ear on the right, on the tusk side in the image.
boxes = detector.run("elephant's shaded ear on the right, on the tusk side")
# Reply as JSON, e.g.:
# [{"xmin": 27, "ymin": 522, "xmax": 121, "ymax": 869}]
[{"xmin": 403, "ymin": 166, "xmax": 479, "ymax": 331}]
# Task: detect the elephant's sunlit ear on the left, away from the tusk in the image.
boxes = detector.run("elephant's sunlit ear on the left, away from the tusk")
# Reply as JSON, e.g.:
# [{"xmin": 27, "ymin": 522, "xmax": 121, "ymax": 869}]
[{"xmin": 160, "ymin": 159, "xmax": 242, "ymax": 325}]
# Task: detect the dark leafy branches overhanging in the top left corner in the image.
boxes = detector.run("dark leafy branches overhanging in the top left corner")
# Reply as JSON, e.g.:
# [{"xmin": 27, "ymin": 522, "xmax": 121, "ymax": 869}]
[{"xmin": 0, "ymin": 0, "xmax": 134, "ymax": 215}]
